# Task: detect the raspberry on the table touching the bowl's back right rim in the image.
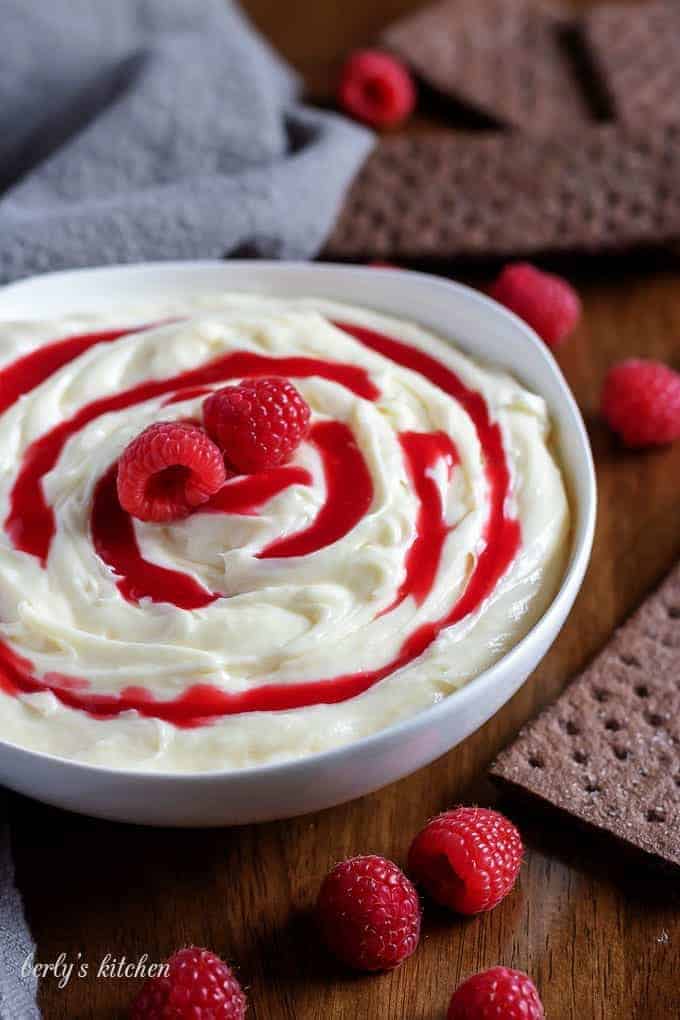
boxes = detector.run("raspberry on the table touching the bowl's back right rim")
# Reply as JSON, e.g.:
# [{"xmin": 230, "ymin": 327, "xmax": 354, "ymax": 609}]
[{"xmin": 489, "ymin": 262, "xmax": 581, "ymax": 347}]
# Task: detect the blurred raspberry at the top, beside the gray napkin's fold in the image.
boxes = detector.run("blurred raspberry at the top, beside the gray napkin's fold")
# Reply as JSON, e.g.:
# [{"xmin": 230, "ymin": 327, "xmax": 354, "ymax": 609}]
[{"xmin": 337, "ymin": 50, "xmax": 416, "ymax": 128}]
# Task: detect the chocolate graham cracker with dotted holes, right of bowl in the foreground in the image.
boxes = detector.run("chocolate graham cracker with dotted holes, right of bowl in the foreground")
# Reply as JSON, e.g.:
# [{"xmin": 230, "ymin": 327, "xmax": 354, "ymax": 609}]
[{"xmin": 490, "ymin": 564, "xmax": 680, "ymax": 868}]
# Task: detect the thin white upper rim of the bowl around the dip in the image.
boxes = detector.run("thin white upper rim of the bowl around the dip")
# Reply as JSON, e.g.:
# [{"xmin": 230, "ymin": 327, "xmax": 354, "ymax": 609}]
[{"xmin": 0, "ymin": 259, "xmax": 597, "ymax": 785}]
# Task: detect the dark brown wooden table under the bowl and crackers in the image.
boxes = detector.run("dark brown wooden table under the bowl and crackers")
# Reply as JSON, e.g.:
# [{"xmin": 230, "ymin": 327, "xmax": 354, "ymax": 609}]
[{"xmin": 12, "ymin": 0, "xmax": 680, "ymax": 1020}]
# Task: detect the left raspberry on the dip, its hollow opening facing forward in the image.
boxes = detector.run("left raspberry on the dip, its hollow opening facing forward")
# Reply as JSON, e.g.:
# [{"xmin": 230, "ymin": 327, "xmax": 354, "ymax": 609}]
[{"xmin": 118, "ymin": 421, "xmax": 226, "ymax": 521}]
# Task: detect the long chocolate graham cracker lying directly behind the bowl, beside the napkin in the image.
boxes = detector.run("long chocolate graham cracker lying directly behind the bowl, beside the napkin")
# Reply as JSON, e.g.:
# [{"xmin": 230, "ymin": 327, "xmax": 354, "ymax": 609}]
[{"xmin": 324, "ymin": 122, "xmax": 680, "ymax": 258}]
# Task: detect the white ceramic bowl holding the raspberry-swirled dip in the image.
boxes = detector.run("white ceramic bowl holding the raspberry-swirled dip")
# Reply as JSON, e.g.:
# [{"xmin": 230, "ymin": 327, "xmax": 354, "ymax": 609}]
[{"xmin": 0, "ymin": 261, "xmax": 595, "ymax": 825}]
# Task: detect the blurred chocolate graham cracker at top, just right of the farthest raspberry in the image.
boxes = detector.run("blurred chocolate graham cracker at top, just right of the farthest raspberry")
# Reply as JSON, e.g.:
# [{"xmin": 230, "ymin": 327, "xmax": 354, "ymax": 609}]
[{"xmin": 380, "ymin": 0, "xmax": 592, "ymax": 134}]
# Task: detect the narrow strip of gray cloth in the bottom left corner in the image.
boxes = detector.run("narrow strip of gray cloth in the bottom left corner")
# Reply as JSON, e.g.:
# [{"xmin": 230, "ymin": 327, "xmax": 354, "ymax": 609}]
[{"xmin": 0, "ymin": 793, "xmax": 40, "ymax": 1020}]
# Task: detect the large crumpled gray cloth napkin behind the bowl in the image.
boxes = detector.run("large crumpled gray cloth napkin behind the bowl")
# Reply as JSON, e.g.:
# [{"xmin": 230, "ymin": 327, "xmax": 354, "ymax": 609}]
[{"xmin": 0, "ymin": 0, "xmax": 371, "ymax": 282}]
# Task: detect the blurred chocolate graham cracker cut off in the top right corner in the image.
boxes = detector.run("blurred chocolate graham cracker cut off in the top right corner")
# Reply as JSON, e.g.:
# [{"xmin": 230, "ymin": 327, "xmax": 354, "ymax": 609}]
[{"xmin": 583, "ymin": 0, "xmax": 680, "ymax": 123}]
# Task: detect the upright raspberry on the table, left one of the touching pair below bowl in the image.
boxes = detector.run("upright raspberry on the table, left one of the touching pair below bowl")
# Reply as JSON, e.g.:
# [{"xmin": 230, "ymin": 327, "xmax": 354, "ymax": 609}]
[{"xmin": 316, "ymin": 856, "xmax": 420, "ymax": 970}]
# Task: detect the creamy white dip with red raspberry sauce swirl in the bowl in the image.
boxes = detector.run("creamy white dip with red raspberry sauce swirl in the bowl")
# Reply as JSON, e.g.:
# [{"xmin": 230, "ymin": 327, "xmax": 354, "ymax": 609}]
[{"xmin": 0, "ymin": 295, "xmax": 569, "ymax": 771}]
